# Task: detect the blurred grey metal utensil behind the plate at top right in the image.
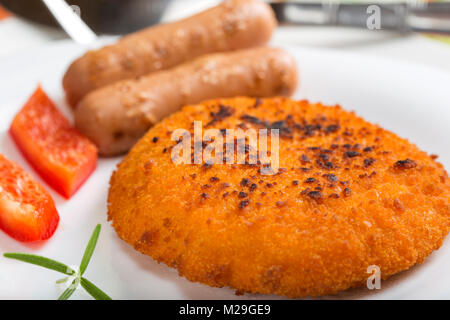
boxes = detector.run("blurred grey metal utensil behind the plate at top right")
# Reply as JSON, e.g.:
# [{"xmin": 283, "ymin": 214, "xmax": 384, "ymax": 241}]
[{"xmin": 271, "ymin": 1, "xmax": 450, "ymax": 34}]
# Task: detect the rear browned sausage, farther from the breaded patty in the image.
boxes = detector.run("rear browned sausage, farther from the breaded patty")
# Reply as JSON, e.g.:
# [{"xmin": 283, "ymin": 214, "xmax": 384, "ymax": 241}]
[{"xmin": 63, "ymin": 0, "xmax": 276, "ymax": 107}]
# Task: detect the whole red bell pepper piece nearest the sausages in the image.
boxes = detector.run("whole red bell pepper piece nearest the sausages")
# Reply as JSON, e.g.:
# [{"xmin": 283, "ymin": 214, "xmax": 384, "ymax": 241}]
[{"xmin": 9, "ymin": 87, "xmax": 97, "ymax": 199}]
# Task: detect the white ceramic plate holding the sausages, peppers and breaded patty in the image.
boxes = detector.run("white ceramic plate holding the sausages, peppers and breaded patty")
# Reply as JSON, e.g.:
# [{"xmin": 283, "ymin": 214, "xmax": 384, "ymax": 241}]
[{"xmin": 0, "ymin": 42, "xmax": 450, "ymax": 299}]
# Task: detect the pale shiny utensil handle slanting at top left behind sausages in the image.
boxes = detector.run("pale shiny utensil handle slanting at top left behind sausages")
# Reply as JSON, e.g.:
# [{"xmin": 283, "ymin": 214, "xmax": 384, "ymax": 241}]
[{"xmin": 42, "ymin": 0, "xmax": 97, "ymax": 44}]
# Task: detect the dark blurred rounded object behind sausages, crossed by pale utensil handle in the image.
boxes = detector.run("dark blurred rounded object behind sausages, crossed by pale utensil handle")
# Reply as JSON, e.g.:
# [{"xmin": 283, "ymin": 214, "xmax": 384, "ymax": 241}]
[{"xmin": 0, "ymin": 0, "xmax": 170, "ymax": 34}]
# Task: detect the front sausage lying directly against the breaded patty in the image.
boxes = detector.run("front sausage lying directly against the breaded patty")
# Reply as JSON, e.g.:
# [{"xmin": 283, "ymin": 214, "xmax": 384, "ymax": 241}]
[{"xmin": 75, "ymin": 47, "xmax": 298, "ymax": 156}]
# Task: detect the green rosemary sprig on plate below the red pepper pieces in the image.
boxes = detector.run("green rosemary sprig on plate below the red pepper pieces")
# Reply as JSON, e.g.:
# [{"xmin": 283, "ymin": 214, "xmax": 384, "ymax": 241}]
[{"xmin": 3, "ymin": 224, "xmax": 111, "ymax": 300}]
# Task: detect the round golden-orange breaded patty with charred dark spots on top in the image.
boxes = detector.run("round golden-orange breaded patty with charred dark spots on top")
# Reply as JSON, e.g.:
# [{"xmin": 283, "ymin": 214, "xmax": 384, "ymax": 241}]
[{"xmin": 108, "ymin": 97, "xmax": 450, "ymax": 297}]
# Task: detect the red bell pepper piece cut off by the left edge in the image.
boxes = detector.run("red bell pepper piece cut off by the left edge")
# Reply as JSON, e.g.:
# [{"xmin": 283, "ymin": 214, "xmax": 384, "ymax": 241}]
[{"xmin": 0, "ymin": 154, "xmax": 59, "ymax": 242}]
